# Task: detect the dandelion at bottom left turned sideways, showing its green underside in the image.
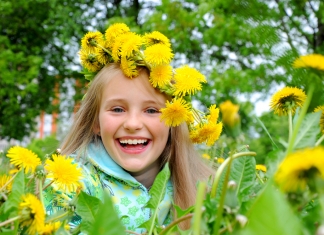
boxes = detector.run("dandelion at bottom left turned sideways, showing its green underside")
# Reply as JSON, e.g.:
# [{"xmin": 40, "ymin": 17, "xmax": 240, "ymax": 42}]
[{"xmin": 19, "ymin": 194, "xmax": 45, "ymax": 235}]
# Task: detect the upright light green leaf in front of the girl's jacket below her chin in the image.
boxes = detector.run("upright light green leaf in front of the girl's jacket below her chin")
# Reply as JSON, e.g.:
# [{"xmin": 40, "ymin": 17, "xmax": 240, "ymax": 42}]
[{"xmin": 140, "ymin": 163, "xmax": 170, "ymax": 234}]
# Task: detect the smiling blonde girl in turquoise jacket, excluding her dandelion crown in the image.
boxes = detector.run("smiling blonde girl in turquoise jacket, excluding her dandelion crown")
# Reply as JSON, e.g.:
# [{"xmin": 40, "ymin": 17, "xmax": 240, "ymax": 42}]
[{"xmin": 61, "ymin": 23, "xmax": 221, "ymax": 233}]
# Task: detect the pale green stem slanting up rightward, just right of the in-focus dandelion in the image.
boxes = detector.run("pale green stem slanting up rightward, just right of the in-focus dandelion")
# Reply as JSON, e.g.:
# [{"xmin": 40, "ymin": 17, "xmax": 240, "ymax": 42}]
[{"xmin": 286, "ymin": 84, "xmax": 314, "ymax": 156}]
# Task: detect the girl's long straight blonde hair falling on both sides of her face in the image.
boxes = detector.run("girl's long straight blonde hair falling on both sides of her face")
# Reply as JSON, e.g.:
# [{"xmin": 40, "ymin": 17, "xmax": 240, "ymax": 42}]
[{"xmin": 61, "ymin": 64, "xmax": 212, "ymax": 227}]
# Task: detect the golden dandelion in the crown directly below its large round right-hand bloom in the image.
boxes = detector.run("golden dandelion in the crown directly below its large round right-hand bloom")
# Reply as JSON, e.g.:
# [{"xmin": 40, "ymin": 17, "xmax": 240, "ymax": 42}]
[{"xmin": 150, "ymin": 65, "xmax": 172, "ymax": 87}]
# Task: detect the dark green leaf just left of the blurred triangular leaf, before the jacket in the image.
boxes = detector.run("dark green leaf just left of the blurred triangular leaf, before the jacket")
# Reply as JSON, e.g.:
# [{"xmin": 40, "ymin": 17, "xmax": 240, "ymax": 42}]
[{"xmin": 76, "ymin": 192, "xmax": 102, "ymax": 231}]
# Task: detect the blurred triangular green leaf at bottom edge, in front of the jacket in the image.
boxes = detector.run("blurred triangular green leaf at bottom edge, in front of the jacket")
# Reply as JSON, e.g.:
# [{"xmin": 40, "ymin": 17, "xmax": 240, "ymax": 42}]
[{"xmin": 89, "ymin": 193, "xmax": 125, "ymax": 235}]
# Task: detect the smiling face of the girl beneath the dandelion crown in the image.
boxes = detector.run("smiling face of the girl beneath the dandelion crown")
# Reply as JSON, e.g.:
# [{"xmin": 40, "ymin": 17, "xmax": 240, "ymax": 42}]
[{"xmin": 95, "ymin": 71, "xmax": 169, "ymax": 175}]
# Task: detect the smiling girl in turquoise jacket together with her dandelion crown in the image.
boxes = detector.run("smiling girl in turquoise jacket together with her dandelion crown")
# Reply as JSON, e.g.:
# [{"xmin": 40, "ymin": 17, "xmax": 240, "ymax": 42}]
[{"xmin": 61, "ymin": 24, "xmax": 221, "ymax": 233}]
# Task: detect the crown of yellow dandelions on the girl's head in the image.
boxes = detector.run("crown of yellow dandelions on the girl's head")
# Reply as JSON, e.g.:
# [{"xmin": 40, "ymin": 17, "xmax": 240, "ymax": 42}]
[{"xmin": 79, "ymin": 23, "xmax": 223, "ymax": 146}]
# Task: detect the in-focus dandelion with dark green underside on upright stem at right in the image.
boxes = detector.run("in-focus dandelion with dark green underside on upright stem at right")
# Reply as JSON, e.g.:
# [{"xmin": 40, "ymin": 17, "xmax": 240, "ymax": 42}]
[{"xmin": 270, "ymin": 87, "xmax": 306, "ymax": 116}]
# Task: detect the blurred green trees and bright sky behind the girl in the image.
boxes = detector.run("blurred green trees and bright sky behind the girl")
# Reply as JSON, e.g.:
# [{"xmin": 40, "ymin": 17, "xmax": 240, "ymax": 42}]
[{"xmin": 0, "ymin": 0, "xmax": 324, "ymax": 163}]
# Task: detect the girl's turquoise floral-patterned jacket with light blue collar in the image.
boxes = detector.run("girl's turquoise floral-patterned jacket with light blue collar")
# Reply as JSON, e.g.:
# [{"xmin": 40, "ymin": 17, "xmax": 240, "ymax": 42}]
[{"xmin": 46, "ymin": 142, "xmax": 173, "ymax": 233}]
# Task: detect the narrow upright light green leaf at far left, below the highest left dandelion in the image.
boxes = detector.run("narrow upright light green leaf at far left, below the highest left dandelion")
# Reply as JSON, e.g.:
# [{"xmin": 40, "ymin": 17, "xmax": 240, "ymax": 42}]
[{"xmin": 4, "ymin": 169, "xmax": 25, "ymax": 213}]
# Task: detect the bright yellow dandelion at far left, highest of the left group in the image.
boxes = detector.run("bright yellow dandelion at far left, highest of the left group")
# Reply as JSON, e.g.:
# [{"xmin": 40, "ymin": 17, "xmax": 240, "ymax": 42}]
[{"xmin": 7, "ymin": 146, "xmax": 41, "ymax": 173}]
